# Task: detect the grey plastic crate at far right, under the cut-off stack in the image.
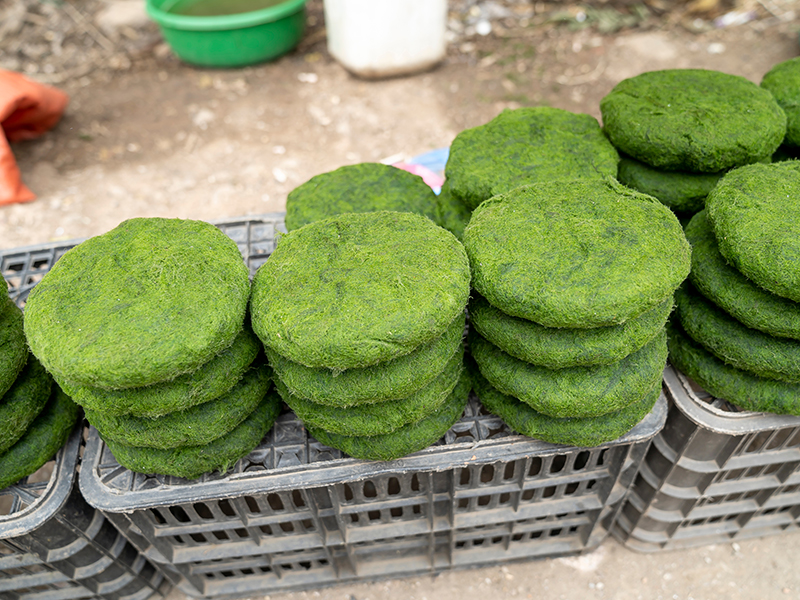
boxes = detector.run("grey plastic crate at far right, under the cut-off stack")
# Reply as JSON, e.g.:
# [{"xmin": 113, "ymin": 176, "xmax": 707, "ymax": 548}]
[{"xmin": 612, "ymin": 368, "xmax": 800, "ymax": 552}]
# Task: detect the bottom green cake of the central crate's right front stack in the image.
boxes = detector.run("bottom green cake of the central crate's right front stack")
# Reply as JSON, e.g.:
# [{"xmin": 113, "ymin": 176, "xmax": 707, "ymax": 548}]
[{"xmin": 473, "ymin": 373, "xmax": 661, "ymax": 448}]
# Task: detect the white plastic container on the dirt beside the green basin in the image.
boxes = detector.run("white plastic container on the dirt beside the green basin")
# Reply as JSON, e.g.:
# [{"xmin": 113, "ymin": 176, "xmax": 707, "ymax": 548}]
[{"xmin": 324, "ymin": 0, "xmax": 447, "ymax": 78}]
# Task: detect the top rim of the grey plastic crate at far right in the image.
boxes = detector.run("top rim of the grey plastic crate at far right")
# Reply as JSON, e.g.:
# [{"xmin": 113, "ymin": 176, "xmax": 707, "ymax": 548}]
[{"xmin": 663, "ymin": 365, "xmax": 800, "ymax": 435}]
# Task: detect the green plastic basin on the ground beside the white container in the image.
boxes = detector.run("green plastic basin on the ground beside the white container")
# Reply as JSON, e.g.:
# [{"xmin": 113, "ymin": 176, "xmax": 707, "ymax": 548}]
[{"xmin": 146, "ymin": 0, "xmax": 306, "ymax": 67}]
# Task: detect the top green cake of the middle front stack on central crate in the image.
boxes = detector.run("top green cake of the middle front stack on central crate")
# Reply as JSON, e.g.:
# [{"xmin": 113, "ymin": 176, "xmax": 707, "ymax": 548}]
[{"xmin": 250, "ymin": 211, "xmax": 470, "ymax": 370}]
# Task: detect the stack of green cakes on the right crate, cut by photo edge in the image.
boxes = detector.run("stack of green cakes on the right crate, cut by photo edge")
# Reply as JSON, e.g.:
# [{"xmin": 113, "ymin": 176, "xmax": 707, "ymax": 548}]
[{"xmin": 669, "ymin": 161, "xmax": 800, "ymax": 414}]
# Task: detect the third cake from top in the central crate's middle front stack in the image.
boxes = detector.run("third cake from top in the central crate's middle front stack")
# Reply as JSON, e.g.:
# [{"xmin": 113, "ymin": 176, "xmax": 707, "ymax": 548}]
[{"xmin": 275, "ymin": 346, "xmax": 464, "ymax": 436}]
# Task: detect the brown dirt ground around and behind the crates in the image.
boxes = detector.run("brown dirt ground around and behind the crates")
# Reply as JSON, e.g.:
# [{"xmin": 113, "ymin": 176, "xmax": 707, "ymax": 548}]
[{"xmin": 0, "ymin": 0, "xmax": 800, "ymax": 600}]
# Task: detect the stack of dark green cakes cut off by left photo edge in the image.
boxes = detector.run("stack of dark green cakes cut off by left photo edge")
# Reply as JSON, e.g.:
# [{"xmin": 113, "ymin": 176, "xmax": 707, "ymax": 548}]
[{"xmin": 0, "ymin": 284, "xmax": 78, "ymax": 489}]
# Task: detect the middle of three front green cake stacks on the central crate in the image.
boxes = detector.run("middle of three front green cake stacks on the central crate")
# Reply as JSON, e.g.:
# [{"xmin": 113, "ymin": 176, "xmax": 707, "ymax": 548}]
[{"xmin": 251, "ymin": 211, "xmax": 470, "ymax": 460}]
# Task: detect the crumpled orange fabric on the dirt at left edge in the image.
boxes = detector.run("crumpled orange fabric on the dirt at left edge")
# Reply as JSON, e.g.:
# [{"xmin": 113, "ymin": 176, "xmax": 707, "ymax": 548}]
[{"xmin": 0, "ymin": 69, "xmax": 69, "ymax": 205}]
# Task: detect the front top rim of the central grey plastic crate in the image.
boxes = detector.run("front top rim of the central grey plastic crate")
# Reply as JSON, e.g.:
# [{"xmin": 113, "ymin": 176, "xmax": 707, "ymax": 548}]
[{"xmin": 79, "ymin": 391, "xmax": 667, "ymax": 513}]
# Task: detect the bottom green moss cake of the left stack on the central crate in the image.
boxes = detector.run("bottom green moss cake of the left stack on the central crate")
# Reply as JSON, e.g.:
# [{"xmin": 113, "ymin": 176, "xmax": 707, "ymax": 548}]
[{"xmin": 101, "ymin": 389, "xmax": 283, "ymax": 479}]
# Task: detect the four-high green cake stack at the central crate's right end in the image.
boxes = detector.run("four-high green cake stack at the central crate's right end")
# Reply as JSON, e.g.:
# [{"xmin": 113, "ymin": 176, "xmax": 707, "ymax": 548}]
[{"xmin": 464, "ymin": 178, "xmax": 690, "ymax": 446}]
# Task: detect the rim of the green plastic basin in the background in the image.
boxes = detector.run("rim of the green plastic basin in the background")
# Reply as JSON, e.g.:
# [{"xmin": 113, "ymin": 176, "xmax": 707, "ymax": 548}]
[{"xmin": 146, "ymin": 0, "xmax": 306, "ymax": 31}]
